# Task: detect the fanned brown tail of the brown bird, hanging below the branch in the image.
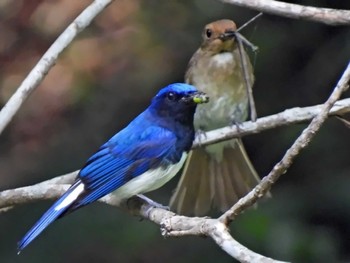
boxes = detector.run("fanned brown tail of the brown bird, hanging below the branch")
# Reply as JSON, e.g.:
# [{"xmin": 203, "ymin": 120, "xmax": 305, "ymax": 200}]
[{"xmin": 170, "ymin": 139, "xmax": 260, "ymax": 216}]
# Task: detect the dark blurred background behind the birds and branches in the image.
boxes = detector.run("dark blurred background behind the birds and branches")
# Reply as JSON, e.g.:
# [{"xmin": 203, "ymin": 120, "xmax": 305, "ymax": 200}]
[{"xmin": 0, "ymin": 0, "xmax": 350, "ymax": 263}]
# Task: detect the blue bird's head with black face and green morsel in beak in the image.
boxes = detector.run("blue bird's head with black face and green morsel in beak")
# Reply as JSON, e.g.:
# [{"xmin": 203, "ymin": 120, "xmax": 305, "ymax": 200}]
[{"xmin": 149, "ymin": 83, "xmax": 209, "ymax": 125}]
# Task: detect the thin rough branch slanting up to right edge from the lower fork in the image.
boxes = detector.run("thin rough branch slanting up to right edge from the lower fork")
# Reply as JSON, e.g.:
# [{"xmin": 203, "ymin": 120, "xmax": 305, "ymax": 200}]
[{"xmin": 220, "ymin": 62, "xmax": 350, "ymax": 224}]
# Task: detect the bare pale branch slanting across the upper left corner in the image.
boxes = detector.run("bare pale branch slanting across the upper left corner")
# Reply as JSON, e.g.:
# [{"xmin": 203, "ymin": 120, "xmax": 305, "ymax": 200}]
[{"xmin": 0, "ymin": 0, "xmax": 112, "ymax": 134}]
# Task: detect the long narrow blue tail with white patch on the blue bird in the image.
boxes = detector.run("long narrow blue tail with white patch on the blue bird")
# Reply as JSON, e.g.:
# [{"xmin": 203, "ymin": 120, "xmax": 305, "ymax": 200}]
[{"xmin": 17, "ymin": 181, "xmax": 84, "ymax": 254}]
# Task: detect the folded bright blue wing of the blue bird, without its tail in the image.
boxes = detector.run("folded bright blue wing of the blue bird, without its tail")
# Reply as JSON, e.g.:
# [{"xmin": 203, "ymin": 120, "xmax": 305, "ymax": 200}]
[{"xmin": 69, "ymin": 127, "xmax": 182, "ymax": 211}]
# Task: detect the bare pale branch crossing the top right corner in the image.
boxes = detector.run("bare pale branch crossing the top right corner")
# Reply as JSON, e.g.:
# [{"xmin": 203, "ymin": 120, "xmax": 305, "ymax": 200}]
[{"xmin": 220, "ymin": 0, "xmax": 350, "ymax": 26}]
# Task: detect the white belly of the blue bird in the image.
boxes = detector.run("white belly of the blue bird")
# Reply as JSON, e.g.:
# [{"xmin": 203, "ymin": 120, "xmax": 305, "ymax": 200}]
[{"xmin": 113, "ymin": 152, "xmax": 187, "ymax": 200}]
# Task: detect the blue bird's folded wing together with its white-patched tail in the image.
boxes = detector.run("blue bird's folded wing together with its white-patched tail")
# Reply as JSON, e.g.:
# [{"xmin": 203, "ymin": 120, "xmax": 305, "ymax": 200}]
[{"xmin": 18, "ymin": 126, "xmax": 178, "ymax": 251}]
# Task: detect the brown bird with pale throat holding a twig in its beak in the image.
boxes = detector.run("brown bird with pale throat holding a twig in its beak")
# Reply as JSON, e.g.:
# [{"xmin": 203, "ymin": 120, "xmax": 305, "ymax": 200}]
[{"xmin": 170, "ymin": 19, "xmax": 260, "ymax": 215}]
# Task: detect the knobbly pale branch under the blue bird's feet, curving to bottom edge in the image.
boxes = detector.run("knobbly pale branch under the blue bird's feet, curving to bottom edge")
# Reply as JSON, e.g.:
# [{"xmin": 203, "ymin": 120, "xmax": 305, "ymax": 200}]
[{"xmin": 0, "ymin": 186, "xmax": 288, "ymax": 263}]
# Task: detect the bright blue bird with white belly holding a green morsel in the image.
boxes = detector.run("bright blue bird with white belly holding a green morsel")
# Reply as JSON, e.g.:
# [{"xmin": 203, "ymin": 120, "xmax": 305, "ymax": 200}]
[{"xmin": 18, "ymin": 83, "xmax": 209, "ymax": 252}]
